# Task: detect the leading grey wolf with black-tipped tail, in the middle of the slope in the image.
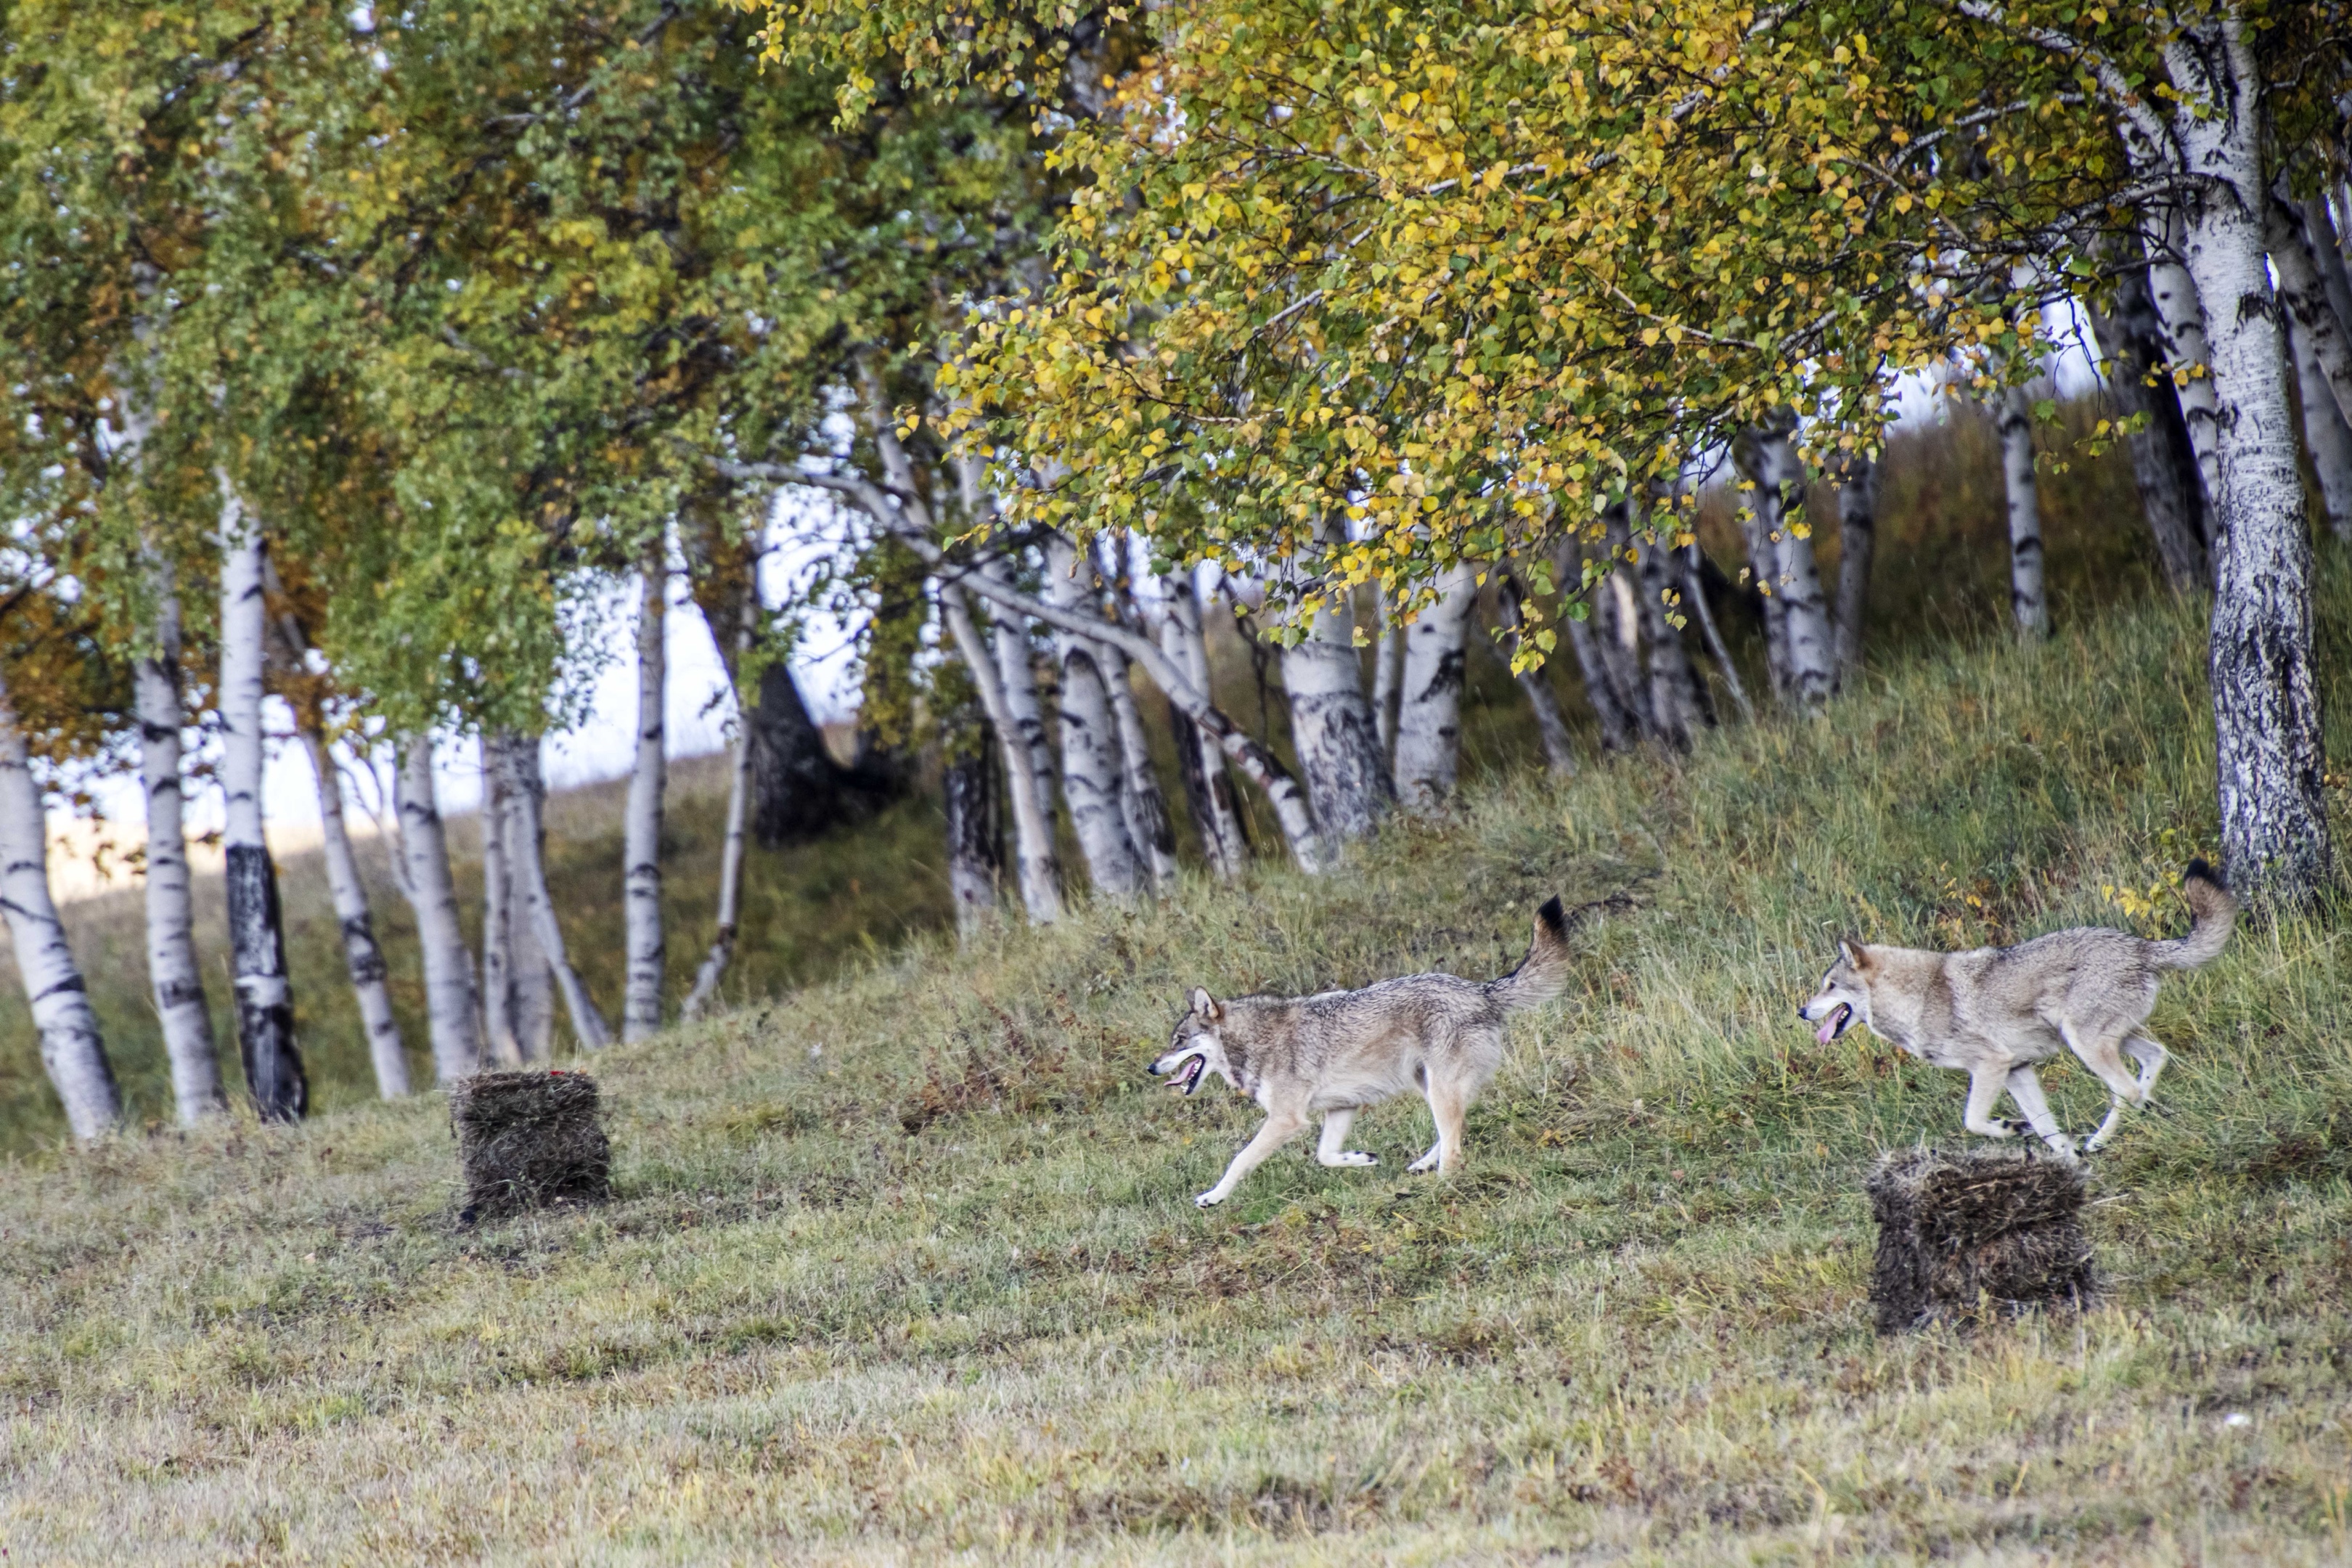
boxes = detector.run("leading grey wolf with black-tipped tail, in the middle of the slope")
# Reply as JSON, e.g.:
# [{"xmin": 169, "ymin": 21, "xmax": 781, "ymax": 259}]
[{"xmin": 1148, "ymin": 898, "xmax": 1569, "ymax": 1209}]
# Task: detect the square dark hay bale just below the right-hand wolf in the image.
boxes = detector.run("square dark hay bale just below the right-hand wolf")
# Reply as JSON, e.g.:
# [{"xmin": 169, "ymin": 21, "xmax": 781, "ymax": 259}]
[{"xmin": 1868, "ymin": 1150, "xmax": 2094, "ymax": 1333}]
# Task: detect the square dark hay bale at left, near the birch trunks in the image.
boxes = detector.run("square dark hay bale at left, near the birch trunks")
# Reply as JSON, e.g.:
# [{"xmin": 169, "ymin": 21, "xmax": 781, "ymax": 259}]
[{"xmin": 449, "ymin": 1072, "xmax": 611, "ymax": 1225}]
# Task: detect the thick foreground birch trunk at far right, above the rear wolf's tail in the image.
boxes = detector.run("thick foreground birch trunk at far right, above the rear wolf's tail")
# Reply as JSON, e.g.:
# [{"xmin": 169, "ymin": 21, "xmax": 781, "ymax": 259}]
[{"xmin": 2180, "ymin": 61, "xmax": 2333, "ymax": 905}]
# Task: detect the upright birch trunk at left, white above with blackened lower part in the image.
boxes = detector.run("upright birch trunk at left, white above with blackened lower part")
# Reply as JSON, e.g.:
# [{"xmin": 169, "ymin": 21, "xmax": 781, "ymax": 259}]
[{"xmin": 216, "ymin": 473, "xmax": 311, "ymax": 1122}]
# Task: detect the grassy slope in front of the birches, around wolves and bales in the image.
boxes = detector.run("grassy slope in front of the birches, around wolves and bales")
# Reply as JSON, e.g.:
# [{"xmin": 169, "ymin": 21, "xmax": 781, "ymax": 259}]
[{"xmin": 0, "ymin": 560, "xmax": 2352, "ymax": 1564}]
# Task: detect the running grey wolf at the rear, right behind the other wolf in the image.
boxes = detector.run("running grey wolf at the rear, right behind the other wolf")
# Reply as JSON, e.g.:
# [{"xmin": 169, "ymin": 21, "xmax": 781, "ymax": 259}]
[{"xmin": 1797, "ymin": 860, "xmax": 2237, "ymax": 1159}]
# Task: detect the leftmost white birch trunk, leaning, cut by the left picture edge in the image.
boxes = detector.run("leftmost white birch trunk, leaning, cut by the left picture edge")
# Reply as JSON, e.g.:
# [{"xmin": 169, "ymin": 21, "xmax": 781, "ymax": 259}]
[{"xmin": 0, "ymin": 677, "xmax": 122, "ymax": 1143}]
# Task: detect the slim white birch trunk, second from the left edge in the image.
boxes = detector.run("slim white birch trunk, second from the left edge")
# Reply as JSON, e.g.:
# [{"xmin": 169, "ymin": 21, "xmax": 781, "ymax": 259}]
[{"xmin": 131, "ymin": 564, "xmax": 228, "ymax": 1126}]
